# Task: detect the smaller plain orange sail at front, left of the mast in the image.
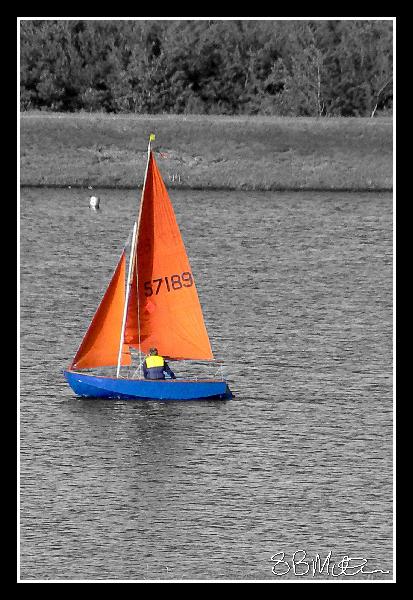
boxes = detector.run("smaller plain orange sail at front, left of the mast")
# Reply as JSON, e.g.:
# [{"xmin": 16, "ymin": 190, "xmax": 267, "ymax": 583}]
[{"xmin": 71, "ymin": 251, "xmax": 131, "ymax": 369}]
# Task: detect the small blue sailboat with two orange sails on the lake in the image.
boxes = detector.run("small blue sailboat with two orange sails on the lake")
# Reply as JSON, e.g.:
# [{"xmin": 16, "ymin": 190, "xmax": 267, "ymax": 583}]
[{"xmin": 64, "ymin": 134, "xmax": 233, "ymax": 400}]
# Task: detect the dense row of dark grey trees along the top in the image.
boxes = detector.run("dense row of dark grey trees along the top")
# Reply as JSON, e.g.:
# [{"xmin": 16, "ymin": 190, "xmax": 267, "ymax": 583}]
[{"xmin": 20, "ymin": 20, "xmax": 393, "ymax": 116}]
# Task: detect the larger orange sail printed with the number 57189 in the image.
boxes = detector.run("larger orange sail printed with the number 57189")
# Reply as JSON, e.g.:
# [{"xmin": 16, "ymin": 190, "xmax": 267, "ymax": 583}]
[{"xmin": 124, "ymin": 151, "xmax": 213, "ymax": 360}]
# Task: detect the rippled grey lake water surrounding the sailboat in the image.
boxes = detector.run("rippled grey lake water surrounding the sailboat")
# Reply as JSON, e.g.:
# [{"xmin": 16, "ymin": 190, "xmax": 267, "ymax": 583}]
[{"xmin": 20, "ymin": 189, "xmax": 393, "ymax": 581}]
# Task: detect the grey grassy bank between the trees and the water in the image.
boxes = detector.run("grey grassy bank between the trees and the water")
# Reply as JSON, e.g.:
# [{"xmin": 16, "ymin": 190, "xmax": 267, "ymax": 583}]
[{"xmin": 20, "ymin": 113, "xmax": 393, "ymax": 190}]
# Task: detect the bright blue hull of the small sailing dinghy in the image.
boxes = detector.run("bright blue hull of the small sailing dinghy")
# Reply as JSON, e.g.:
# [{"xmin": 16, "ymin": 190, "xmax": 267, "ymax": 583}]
[{"xmin": 63, "ymin": 371, "xmax": 233, "ymax": 400}]
